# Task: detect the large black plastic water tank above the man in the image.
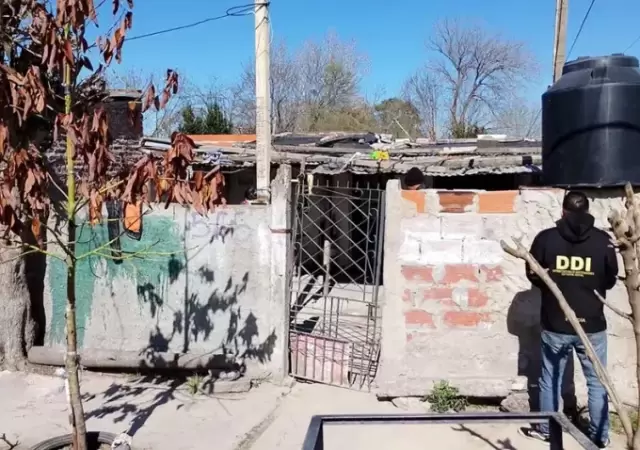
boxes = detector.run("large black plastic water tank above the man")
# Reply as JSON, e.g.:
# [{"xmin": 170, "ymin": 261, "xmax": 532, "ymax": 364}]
[{"xmin": 542, "ymin": 54, "xmax": 640, "ymax": 187}]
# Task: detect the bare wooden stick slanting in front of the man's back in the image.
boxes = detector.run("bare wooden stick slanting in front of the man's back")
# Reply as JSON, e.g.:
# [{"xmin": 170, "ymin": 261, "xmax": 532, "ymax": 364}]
[{"xmin": 500, "ymin": 238, "xmax": 633, "ymax": 449}]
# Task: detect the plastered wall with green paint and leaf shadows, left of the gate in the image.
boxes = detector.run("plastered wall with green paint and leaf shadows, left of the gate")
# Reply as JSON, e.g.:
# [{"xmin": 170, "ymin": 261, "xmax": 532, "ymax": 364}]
[{"xmin": 44, "ymin": 205, "xmax": 286, "ymax": 376}]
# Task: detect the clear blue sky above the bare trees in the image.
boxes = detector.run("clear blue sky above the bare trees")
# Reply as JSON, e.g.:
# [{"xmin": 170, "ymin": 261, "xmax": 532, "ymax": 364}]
[{"xmin": 107, "ymin": 0, "xmax": 640, "ymax": 103}]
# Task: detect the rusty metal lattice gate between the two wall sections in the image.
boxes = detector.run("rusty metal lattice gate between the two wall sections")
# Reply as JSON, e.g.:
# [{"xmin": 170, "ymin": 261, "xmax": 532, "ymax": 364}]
[{"xmin": 289, "ymin": 180, "xmax": 385, "ymax": 389}]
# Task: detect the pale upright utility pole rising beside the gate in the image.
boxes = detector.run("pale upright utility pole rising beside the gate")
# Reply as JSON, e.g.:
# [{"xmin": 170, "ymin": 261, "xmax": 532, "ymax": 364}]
[{"xmin": 255, "ymin": 0, "xmax": 271, "ymax": 202}]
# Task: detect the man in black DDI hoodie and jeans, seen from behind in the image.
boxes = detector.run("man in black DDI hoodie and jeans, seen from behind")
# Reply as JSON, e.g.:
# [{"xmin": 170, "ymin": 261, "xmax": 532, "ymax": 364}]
[{"xmin": 522, "ymin": 191, "xmax": 618, "ymax": 448}]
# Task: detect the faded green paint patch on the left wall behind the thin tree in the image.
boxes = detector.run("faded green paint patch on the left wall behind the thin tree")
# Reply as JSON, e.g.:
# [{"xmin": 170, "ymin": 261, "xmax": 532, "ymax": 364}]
[{"xmin": 48, "ymin": 215, "xmax": 185, "ymax": 346}]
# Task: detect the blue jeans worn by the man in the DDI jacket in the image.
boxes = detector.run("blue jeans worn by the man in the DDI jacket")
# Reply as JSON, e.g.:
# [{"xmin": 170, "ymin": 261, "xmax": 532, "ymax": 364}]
[{"xmin": 539, "ymin": 331, "xmax": 609, "ymax": 442}]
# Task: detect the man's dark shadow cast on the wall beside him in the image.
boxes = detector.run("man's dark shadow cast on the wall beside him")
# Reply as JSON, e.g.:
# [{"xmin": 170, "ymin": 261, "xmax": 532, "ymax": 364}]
[{"xmin": 507, "ymin": 287, "xmax": 577, "ymax": 416}]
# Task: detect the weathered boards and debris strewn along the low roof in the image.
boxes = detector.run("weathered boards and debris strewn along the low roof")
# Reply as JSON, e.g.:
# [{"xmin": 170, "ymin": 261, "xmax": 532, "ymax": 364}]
[{"xmin": 141, "ymin": 133, "xmax": 542, "ymax": 177}]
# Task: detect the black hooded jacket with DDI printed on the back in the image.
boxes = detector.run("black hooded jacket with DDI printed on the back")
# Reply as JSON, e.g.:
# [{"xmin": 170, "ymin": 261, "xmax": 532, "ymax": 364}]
[{"xmin": 526, "ymin": 213, "xmax": 618, "ymax": 334}]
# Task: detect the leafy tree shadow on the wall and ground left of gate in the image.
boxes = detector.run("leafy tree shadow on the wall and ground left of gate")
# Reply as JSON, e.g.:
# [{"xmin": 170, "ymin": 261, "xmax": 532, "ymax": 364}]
[{"xmin": 85, "ymin": 256, "xmax": 278, "ymax": 436}]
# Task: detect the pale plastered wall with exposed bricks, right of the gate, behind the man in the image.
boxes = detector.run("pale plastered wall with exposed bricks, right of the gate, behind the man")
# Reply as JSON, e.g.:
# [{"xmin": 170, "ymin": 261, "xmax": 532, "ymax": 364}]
[{"xmin": 377, "ymin": 181, "xmax": 636, "ymax": 402}]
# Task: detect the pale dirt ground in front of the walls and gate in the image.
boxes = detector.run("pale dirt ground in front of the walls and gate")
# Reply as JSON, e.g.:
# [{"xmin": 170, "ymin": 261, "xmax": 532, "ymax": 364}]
[{"xmin": 0, "ymin": 372, "xmax": 624, "ymax": 450}]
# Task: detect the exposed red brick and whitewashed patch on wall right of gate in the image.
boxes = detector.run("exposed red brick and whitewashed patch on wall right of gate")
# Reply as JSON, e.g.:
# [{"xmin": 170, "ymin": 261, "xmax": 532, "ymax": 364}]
[{"xmin": 400, "ymin": 191, "xmax": 517, "ymax": 336}]
